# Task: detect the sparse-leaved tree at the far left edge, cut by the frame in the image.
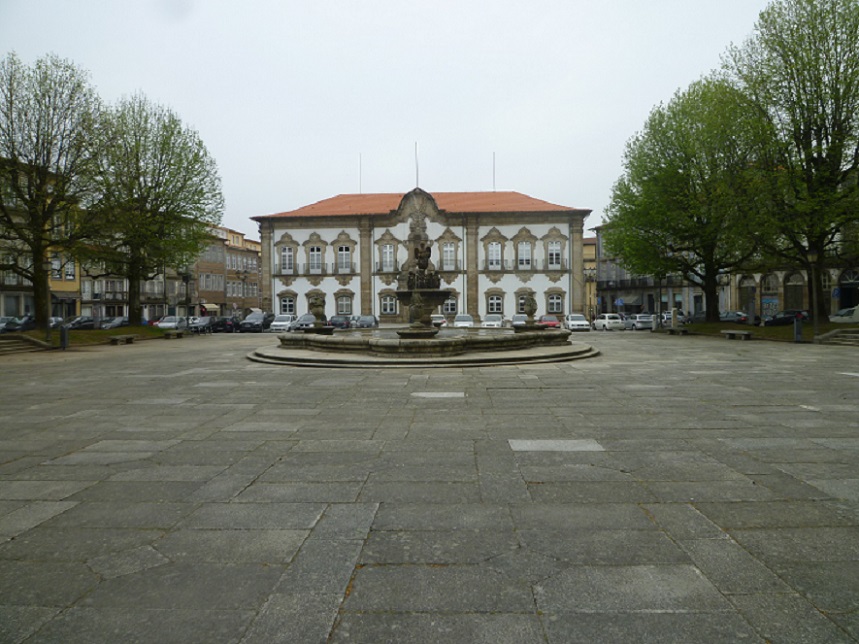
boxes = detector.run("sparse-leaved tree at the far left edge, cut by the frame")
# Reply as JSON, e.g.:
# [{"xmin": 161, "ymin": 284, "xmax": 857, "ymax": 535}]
[{"xmin": 0, "ymin": 53, "xmax": 100, "ymax": 328}]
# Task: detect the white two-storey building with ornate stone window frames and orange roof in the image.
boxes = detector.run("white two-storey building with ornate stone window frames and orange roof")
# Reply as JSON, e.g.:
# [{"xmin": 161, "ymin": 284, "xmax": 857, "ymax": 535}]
[{"xmin": 253, "ymin": 188, "xmax": 591, "ymax": 322}]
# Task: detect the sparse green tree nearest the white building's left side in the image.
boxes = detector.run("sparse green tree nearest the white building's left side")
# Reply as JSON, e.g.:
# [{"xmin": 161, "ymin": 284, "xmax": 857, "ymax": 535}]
[{"xmin": 90, "ymin": 95, "xmax": 224, "ymax": 322}]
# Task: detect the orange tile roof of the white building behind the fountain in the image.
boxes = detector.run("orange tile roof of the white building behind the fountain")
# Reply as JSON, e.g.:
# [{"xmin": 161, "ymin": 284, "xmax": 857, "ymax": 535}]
[{"xmin": 251, "ymin": 192, "xmax": 590, "ymax": 221}]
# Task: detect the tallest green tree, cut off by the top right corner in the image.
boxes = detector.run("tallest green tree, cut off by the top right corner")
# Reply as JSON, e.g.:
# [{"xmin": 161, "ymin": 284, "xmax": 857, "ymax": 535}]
[{"xmin": 725, "ymin": 0, "xmax": 859, "ymax": 315}]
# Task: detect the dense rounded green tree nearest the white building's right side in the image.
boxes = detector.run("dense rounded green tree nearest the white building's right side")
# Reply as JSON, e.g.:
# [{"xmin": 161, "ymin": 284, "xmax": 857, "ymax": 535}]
[{"xmin": 603, "ymin": 77, "xmax": 766, "ymax": 321}]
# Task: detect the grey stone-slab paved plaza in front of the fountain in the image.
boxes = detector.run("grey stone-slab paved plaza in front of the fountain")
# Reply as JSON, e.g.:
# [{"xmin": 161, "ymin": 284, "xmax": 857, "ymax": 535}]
[{"xmin": 0, "ymin": 331, "xmax": 859, "ymax": 644}]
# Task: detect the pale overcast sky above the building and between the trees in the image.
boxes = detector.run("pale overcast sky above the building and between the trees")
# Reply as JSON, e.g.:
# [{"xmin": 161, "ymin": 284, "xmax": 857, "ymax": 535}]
[{"xmin": 0, "ymin": 0, "xmax": 768, "ymax": 239}]
